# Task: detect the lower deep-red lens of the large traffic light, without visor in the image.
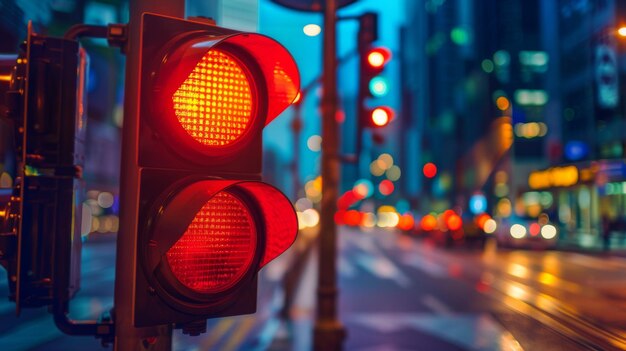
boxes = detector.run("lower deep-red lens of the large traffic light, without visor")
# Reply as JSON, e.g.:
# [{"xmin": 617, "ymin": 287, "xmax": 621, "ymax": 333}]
[{"xmin": 166, "ymin": 191, "xmax": 257, "ymax": 293}]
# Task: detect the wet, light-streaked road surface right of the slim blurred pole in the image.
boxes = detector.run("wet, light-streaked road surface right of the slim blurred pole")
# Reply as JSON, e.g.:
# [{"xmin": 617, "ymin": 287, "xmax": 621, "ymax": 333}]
[{"xmin": 332, "ymin": 229, "xmax": 626, "ymax": 350}]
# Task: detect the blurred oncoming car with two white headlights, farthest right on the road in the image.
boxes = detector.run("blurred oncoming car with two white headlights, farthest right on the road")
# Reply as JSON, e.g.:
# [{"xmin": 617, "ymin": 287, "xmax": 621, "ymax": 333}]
[{"xmin": 495, "ymin": 215, "xmax": 559, "ymax": 249}]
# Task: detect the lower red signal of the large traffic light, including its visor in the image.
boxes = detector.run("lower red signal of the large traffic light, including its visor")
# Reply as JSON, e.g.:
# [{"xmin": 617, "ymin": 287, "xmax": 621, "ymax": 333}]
[{"xmin": 145, "ymin": 180, "xmax": 298, "ymax": 304}]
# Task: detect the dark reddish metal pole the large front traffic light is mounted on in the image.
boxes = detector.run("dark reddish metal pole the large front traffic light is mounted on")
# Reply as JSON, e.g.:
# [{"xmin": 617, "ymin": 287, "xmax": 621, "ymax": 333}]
[{"xmin": 114, "ymin": 0, "xmax": 185, "ymax": 351}]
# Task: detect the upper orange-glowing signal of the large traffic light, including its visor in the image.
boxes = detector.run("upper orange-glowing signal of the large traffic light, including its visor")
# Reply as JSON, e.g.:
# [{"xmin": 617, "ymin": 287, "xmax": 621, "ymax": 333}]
[{"xmin": 152, "ymin": 32, "xmax": 300, "ymax": 156}]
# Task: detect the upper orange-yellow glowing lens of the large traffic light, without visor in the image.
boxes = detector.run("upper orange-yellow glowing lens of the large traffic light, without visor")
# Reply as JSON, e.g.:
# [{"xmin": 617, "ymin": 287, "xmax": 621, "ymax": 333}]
[{"xmin": 172, "ymin": 49, "xmax": 254, "ymax": 147}]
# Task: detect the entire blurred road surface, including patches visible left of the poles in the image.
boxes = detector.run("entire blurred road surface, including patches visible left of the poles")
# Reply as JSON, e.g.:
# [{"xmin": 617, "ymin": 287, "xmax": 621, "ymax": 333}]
[{"xmin": 0, "ymin": 228, "xmax": 626, "ymax": 351}]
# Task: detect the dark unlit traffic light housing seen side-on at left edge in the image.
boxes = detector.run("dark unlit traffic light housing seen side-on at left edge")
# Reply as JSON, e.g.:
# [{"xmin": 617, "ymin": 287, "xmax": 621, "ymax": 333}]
[{"xmin": 0, "ymin": 24, "xmax": 87, "ymax": 316}]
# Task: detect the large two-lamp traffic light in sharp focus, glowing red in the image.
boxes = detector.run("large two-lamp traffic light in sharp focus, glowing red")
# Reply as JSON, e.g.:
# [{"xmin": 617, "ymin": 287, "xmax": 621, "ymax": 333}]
[{"xmin": 120, "ymin": 13, "xmax": 299, "ymax": 334}]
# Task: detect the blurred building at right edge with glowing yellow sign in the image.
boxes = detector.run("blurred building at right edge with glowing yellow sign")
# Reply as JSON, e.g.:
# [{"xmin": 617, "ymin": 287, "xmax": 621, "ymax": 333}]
[{"xmin": 529, "ymin": 0, "xmax": 626, "ymax": 247}]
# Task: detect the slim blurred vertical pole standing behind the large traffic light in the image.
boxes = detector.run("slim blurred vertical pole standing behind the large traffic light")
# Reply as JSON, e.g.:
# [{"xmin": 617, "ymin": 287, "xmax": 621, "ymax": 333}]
[{"xmin": 313, "ymin": 0, "xmax": 346, "ymax": 351}]
